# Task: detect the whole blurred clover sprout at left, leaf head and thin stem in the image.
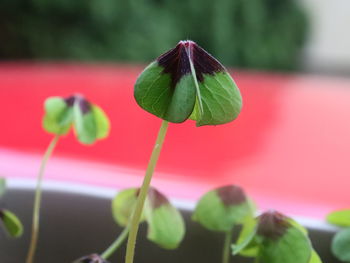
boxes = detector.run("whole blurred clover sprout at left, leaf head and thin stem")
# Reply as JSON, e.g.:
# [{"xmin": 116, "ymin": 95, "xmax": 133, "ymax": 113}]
[{"xmin": 26, "ymin": 95, "xmax": 110, "ymax": 263}]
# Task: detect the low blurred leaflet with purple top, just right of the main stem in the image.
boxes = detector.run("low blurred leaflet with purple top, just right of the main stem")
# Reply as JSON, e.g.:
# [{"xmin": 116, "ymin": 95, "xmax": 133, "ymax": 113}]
[{"xmin": 144, "ymin": 188, "xmax": 185, "ymax": 249}]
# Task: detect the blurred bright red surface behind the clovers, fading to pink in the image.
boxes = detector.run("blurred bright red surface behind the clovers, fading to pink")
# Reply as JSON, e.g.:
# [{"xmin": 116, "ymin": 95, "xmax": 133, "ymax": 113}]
[{"xmin": 0, "ymin": 63, "xmax": 350, "ymax": 217}]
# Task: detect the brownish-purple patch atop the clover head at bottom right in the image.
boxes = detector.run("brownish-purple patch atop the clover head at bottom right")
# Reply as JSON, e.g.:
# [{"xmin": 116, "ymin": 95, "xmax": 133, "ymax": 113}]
[{"xmin": 257, "ymin": 211, "xmax": 290, "ymax": 240}]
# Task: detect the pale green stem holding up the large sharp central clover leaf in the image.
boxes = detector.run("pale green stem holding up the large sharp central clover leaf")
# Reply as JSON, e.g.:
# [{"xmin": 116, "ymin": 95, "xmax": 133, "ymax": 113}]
[{"xmin": 125, "ymin": 120, "xmax": 168, "ymax": 263}]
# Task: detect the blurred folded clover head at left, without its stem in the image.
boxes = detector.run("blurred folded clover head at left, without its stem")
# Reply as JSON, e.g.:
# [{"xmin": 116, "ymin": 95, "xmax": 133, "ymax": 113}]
[{"xmin": 43, "ymin": 95, "xmax": 110, "ymax": 144}]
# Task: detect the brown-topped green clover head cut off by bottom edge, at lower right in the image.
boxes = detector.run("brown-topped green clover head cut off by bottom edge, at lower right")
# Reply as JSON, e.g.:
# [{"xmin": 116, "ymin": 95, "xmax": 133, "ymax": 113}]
[{"xmin": 232, "ymin": 211, "xmax": 321, "ymax": 263}]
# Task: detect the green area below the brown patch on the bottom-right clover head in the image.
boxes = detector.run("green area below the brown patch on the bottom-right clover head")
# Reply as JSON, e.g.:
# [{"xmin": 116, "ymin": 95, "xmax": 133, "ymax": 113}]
[{"xmin": 258, "ymin": 226, "xmax": 312, "ymax": 263}]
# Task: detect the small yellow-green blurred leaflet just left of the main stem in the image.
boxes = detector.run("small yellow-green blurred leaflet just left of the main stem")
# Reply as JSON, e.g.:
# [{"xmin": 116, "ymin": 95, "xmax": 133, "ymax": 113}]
[{"xmin": 112, "ymin": 188, "xmax": 144, "ymax": 227}]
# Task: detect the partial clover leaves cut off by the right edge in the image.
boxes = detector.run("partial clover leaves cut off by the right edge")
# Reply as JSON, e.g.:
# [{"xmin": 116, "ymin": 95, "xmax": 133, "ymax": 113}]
[{"xmin": 327, "ymin": 209, "xmax": 350, "ymax": 262}]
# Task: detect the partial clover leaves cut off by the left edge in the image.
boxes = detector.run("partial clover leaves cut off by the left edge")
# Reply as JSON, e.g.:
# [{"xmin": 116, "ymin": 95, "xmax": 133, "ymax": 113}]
[{"xmin": 0, "ymin": 178, "xmax": 23, "ymax": 237}]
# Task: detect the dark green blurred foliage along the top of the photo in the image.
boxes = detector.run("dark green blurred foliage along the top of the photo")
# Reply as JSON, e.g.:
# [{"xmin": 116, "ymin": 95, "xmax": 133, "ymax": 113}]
[{"xmin": 0, "ymin": 0, "xmax": 308, "ymax": 70}]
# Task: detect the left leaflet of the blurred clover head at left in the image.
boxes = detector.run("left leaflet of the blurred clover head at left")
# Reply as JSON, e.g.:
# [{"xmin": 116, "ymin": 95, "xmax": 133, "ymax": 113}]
[{"xmin": 43, "ymin": 97, "xmax": 73, "ymax": 135}]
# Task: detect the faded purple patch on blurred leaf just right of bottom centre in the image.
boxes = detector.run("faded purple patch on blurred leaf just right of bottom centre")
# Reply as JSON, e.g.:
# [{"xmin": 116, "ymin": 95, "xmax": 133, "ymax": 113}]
[{"xmin": 216, "ymin": 185, "xmax": 247, "ymax": 206}]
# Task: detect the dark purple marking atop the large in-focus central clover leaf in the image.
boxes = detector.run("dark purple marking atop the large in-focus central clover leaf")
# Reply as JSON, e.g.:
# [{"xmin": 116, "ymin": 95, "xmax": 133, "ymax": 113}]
[{"xmin": 157, "ymin": 40, "xmax": 225, "ymax": 88}]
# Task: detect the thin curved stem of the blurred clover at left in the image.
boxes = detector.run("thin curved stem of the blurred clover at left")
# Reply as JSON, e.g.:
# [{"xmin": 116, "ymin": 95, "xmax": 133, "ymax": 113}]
[{"xmin": 26, "ymin": 135, "xmax": 60, "ymax": 263}]
